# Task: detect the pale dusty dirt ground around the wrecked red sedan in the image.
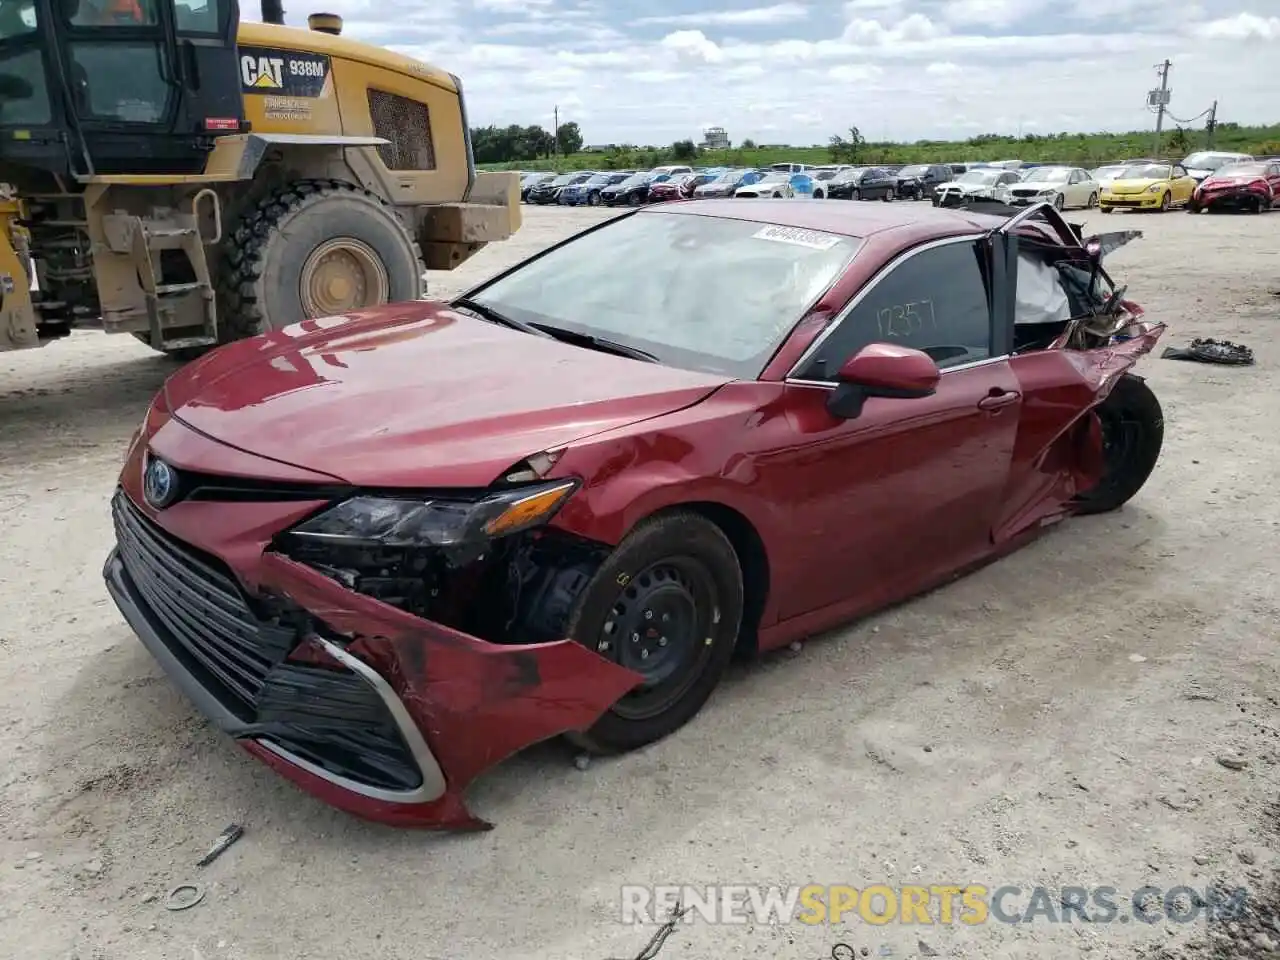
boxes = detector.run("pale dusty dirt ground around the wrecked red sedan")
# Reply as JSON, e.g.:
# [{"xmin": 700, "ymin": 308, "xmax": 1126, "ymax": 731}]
[{"xmin": 0, "ymin": 199, "xmax": 1280, "ymax": 960}]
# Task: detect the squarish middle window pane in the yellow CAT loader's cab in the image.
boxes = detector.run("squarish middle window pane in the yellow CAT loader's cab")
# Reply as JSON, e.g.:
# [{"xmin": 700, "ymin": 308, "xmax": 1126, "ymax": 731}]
[{"xmin": 70, "ymin": 41, "xmax": 172, "ymax": 123}]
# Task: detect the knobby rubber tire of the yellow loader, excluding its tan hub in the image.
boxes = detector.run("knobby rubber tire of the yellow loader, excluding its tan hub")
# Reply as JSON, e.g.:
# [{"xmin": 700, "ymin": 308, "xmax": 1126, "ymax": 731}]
[{"xmin": 218, "ymin": 180, "xmax": 426, "ymax": 342}]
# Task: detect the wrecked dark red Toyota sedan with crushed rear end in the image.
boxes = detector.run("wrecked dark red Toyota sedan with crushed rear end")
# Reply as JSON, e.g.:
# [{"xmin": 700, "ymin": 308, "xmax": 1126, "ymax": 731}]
[{"xmin": 104, "ymin": 200, "xmax": 1164, "ymax": 829}]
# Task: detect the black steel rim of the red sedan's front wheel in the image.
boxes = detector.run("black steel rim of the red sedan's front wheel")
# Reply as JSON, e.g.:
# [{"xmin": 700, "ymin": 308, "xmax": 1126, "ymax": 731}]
[{"xmin": 595, "ymin": 557, "xmax": 721, "ymax": 721}]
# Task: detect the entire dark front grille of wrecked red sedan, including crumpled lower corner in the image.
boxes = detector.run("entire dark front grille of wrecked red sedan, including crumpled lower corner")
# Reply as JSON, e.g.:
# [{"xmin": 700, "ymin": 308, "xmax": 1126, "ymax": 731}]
[{"xmin": 111, "ymin": 490, "xmax": 422, "ymax": 791}]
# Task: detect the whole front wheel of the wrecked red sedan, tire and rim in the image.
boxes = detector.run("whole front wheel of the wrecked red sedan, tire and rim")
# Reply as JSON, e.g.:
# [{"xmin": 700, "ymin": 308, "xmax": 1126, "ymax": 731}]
[{"xmin": 567, "ymin": 511, "xmax": 742, "ymax": 754}]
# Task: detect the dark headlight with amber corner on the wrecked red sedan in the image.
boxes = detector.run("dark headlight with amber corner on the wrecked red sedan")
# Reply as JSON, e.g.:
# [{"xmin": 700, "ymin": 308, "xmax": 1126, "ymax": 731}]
[{"xmin": 289, "ymin": 480, "xmax": 577, "ymax": 547}]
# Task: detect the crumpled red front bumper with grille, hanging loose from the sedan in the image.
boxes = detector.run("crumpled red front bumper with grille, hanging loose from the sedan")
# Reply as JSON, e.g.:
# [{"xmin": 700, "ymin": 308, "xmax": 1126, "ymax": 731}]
[{"xmin": 104, "ymin": 478, "xmax": 640, "ymax": 829}]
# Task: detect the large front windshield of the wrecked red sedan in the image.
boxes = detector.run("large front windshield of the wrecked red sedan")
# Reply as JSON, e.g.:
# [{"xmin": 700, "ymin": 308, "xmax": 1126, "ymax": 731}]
[{"xmin": 472, "ymin": 212, "xmax": 860, "ymax": 379}]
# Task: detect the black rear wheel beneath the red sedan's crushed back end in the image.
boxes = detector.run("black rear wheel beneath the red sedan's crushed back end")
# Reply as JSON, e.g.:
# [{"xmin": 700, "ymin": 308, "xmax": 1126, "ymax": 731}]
[{"xmin": 1075, "ymin": 374, "xmax": 1165, "ymax": 513}]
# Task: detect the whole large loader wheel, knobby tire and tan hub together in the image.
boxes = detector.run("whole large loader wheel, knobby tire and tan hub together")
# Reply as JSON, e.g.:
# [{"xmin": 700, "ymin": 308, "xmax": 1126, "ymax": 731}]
[{"xmin": 216, "ymin": 180, "xmax": 426, "ymax": 343}]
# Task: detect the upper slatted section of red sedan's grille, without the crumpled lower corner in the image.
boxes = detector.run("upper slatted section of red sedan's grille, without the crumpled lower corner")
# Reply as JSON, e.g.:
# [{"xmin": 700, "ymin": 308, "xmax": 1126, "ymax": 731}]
[{"xmin": 111, "ymin": 492, "xmax": 298, "ymax": 721}]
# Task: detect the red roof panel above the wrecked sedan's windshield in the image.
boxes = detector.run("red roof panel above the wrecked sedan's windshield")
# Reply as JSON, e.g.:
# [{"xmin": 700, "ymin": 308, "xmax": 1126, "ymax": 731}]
[{"xmin": 641, "ymin": 198, "xmax": 1005, "ymax": 239}]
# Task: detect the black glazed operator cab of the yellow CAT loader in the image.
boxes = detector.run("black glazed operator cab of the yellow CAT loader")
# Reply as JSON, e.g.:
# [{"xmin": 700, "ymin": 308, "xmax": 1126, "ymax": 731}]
[{"xmin": 0, "ymin": 0, "xmax": 244, "ymax": 180}]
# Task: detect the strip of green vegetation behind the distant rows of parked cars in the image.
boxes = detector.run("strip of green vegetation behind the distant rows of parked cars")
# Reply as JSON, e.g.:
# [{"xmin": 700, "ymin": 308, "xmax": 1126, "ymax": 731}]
[{"xmin": 481, "ymin": 123, "xmax": 1280, "ymax": 170}]
